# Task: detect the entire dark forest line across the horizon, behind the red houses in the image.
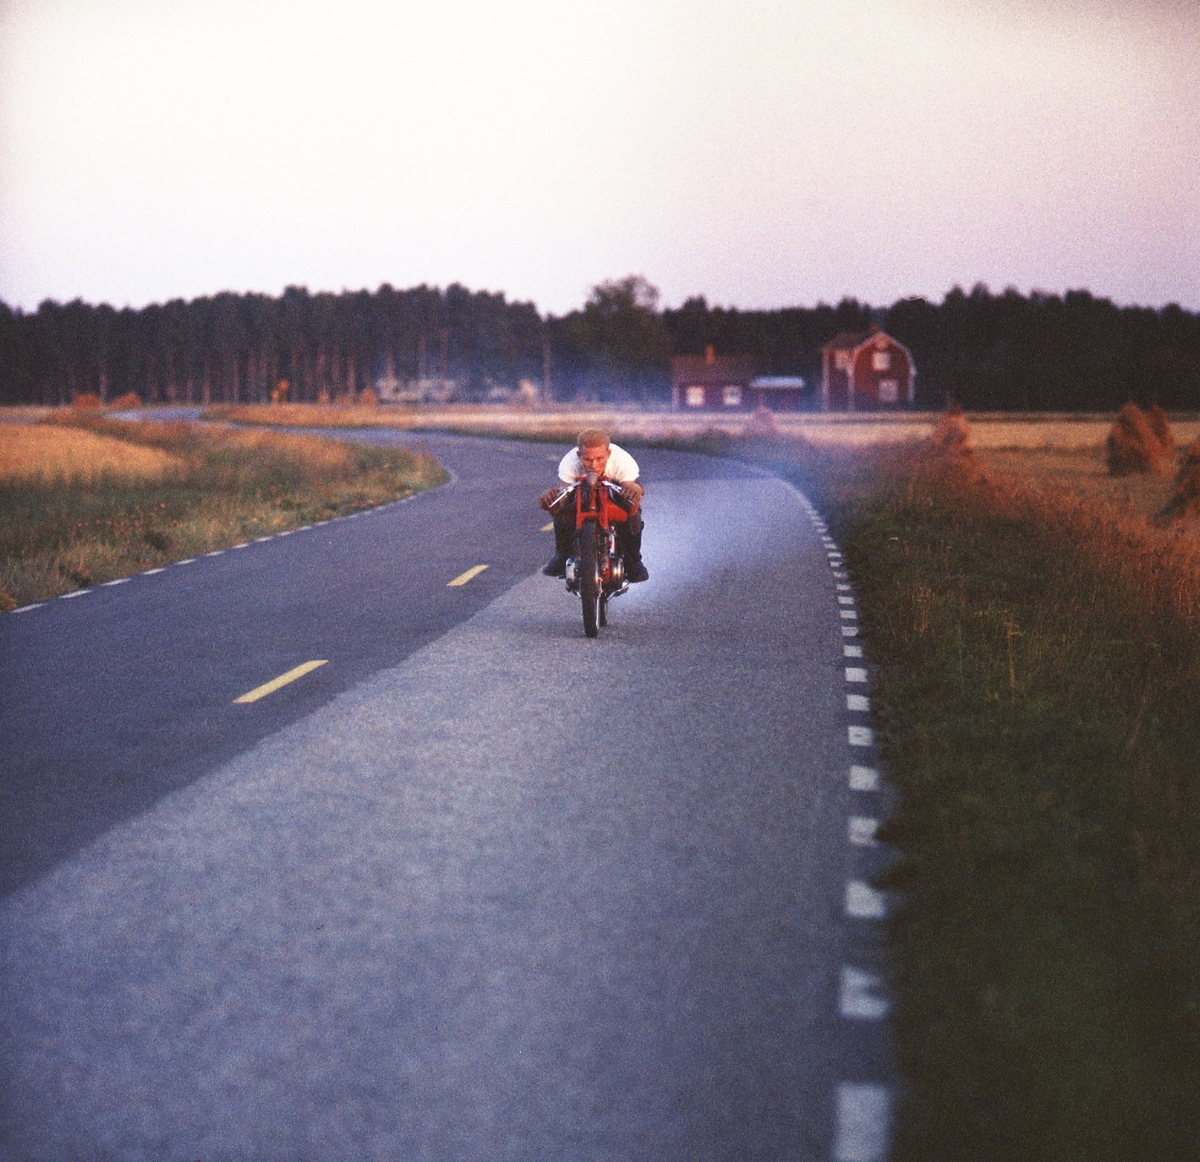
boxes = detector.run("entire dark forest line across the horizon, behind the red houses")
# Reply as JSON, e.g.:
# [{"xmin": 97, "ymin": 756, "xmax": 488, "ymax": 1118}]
[{"xmin": 0, "ymin": 276, "xmax": 1200, "ymax": 411}]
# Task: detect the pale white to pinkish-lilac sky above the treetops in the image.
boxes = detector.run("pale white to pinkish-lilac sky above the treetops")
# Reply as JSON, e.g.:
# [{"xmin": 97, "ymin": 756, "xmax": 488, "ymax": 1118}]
[{"xmin": 0, "ymin": 0, "xmax": 1200, "ymax": 313}]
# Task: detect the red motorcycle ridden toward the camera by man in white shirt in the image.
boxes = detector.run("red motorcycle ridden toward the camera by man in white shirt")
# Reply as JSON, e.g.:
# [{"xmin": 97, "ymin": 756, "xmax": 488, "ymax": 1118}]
[{"xmin": 554, "ymin": 473, "xmax": 630, "ymax": 637}]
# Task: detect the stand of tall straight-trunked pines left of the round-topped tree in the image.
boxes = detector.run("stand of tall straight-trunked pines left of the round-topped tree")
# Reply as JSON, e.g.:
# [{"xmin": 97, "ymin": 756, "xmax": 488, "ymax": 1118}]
[{"xmin": 0, "ymin": 283, "xmax": 545, "ymax": 405}]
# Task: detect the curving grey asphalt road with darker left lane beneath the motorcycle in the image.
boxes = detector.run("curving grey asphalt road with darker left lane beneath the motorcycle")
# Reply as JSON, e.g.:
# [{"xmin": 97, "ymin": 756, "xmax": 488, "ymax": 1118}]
[{"xmin": 0, "ymin": 433, "xmax": 892, "ymax": 1162}]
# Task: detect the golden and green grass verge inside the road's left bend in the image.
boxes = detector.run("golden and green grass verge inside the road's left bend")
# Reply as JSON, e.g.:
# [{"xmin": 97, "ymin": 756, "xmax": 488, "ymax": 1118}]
[{"xmin": 0, "ymin": 418, "xmax": 445, "ymax": 609}]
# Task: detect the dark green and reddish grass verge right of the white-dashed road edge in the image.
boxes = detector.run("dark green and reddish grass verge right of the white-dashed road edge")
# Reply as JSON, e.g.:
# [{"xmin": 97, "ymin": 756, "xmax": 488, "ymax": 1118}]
[{"xmin": 732, "ymin": 436, "xmax": 1200, "ymax": 1162}]
